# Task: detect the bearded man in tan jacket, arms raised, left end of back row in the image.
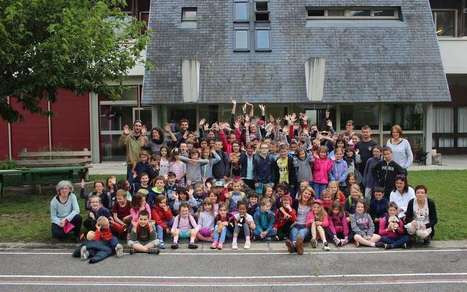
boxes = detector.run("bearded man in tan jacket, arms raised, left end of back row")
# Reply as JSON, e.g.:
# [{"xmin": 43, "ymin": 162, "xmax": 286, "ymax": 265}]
[{"xmin": 119, "ymin": 120, "xmax": 148, "ymax": 184}]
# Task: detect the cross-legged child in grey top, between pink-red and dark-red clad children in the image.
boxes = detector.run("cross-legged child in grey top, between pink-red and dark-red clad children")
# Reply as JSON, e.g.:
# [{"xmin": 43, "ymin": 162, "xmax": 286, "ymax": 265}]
[{"xmin": 350, "ymin": 199, "xmax": 381, "ymax": 247}]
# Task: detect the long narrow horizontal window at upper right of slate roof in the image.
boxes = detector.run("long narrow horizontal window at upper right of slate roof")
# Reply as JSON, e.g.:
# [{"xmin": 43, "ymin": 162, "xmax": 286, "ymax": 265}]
[{"xmin": 307, "ymin": 7, "xmax": 401, "ymax": 19}]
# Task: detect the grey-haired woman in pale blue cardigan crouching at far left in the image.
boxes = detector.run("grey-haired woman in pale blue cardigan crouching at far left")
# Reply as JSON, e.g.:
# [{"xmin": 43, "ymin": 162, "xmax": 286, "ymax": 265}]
[{"xmin": 50, "ymin": 180, "xmax": 82, "ymax": 240}]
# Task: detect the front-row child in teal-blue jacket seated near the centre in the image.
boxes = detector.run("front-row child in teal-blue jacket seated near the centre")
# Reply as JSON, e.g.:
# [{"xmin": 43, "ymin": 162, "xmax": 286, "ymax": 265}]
[{"xmin": 254, "ymin": 198, "xmax": 277, "ymax": 241}]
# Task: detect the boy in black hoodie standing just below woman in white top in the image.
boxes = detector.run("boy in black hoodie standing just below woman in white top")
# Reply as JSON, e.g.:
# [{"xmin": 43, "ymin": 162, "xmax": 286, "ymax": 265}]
[{"xmin": 373, "ymin": 147, "xmax": 405, "ymax": 199}]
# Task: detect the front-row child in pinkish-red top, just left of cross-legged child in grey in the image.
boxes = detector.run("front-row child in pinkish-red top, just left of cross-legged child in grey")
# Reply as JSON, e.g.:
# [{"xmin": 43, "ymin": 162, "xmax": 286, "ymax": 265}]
[{"xmin": 325, "ymin": 202, "xmax": 350, "ymax": 247}]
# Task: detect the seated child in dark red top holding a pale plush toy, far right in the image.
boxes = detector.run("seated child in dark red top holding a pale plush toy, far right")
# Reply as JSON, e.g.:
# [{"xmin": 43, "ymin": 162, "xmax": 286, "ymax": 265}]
[{"xmin": 376, "ymin": 202, "xmax": 409, "ymax": 249}]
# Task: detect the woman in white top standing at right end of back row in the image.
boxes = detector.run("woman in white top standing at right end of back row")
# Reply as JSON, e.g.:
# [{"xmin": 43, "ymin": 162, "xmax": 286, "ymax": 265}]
[{"xmin": 386, "ymin": 125, "xmax": 413, "ymax": 173}]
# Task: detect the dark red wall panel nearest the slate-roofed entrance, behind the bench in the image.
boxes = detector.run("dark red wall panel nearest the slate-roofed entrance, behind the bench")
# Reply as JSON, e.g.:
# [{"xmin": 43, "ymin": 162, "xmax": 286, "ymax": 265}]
[{"xmin": 51, "ymin": 90, "xmax": 90, "ymax": 150}]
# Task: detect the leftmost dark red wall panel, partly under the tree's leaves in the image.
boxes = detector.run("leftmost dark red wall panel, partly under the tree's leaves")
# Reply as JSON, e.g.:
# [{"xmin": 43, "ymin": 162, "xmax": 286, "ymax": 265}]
[{"xmin": 10, "ymin": 98, "xmax": 49, "ymax": 158}]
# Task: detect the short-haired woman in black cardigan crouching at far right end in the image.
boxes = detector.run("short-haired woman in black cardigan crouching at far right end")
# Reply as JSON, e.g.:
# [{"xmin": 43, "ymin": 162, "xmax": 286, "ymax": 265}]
[{"xmin": 405, "ymin": 185, "xmax": 438, "ymax": 244}]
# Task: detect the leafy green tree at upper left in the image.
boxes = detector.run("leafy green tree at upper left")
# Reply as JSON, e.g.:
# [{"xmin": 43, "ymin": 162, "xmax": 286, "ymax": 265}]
[{"xmin": 0, "ymin": 0, "xmax": 148, "ymax": 122}]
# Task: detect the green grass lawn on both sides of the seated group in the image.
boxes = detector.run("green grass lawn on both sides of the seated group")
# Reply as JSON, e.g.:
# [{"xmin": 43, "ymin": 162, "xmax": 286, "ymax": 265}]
[{"xmin": 0, "ymin": 171, "xmax": 467, "ymax": 242}]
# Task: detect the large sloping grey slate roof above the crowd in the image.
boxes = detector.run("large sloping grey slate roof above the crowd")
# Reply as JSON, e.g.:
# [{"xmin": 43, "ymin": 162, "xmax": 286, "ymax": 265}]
[{"xmin": 143, "ymin": 0, "xmax": 451, "ymax": 104}]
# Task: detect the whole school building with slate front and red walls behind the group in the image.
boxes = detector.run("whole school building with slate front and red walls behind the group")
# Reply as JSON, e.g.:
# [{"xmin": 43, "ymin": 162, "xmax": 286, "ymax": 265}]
[{"xmin": 0, "ymin": 0, "xmax": 467, "ymax": 162}]
